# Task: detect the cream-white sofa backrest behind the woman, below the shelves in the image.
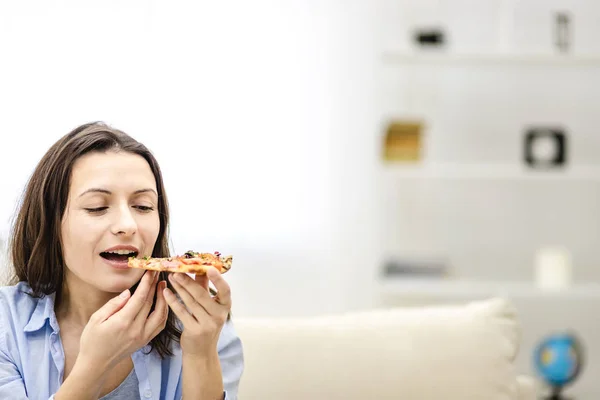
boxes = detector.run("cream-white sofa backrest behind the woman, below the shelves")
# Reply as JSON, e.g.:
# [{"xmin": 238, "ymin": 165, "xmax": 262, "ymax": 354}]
[{"xmin": 234, "ymin": 298, "xmax": 536, "ymax": 400}]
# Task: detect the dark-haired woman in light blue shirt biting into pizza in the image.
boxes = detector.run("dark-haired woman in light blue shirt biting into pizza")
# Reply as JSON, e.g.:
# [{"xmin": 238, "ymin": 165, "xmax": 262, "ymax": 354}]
[{"xmin": 0, "ymin": 123, "xmax": 243, "ymax": 400}]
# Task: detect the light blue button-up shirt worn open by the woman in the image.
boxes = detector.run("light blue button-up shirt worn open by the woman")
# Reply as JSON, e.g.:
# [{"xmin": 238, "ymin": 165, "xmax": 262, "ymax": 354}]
[{"xmin": 0, "ymin": 282, "xmax": 244, "ymax": 400}]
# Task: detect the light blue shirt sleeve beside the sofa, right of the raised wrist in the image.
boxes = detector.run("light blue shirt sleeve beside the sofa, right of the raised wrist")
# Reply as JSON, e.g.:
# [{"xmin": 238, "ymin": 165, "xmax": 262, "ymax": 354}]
[{"xmin": 218, "ymin": 318, "xmax": 244, "ymax": 400}]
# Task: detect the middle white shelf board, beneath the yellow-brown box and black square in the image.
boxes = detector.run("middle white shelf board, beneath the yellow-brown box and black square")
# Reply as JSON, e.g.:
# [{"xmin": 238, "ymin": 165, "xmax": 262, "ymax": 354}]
[{"xmin": 382, "ymin": 162, "xmax": 600, "ymax": 183}]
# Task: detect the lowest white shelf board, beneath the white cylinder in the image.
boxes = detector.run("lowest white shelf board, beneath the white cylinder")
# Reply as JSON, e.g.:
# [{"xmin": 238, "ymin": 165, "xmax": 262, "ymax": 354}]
[{"xmin": 380, "ymin": 278, "xmax": 600, "ymax": 299}]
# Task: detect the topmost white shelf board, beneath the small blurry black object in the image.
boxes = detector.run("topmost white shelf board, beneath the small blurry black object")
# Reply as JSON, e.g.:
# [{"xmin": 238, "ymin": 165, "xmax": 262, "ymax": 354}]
[{"xmin": 383, "ymin": 51, "xmax": 600, "ymax": 67}]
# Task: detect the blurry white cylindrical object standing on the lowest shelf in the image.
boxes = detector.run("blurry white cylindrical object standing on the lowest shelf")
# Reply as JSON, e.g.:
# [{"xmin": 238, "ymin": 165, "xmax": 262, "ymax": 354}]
[{"xmin": 535, "ymin": 247, "xmax": 573, "ymax": 290}]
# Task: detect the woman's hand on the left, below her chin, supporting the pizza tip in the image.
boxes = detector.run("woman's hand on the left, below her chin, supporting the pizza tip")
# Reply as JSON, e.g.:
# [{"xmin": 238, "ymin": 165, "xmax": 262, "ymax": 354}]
[{"xmin": 76, "ymin": 271, "xmax": 168, "ymax": 371}]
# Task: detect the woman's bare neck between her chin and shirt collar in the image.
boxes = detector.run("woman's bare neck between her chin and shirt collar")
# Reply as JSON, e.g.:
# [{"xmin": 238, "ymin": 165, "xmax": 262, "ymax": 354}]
[{"xmin": 54, "ymin": 272, "xmax": 114, "ymax": 329}]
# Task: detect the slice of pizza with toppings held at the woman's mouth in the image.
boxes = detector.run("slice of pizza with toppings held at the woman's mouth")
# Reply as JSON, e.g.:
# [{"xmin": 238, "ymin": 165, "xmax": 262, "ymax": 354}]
[{"xmin": 127, "ymin": 250, "xmax": 233, "ymax": 275}]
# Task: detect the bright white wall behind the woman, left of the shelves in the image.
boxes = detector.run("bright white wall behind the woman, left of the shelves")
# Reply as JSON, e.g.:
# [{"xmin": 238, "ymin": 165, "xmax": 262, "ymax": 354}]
[{"xmin": 0, "ymin": 0, "xmax": 378, "ymax": 315}]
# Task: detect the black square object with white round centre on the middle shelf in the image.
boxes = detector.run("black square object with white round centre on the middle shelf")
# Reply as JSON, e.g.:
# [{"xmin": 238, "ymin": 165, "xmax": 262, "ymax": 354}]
[{"xmin": 524, "ymin": 127, "xmax": 567, "ymax": 168}]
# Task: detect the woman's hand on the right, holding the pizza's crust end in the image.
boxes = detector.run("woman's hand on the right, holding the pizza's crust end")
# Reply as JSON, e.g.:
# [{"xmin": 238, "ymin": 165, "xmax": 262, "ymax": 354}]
[{"xmin": 164, "ymin": 268, "xmax": 231, "ymax": 358}]
